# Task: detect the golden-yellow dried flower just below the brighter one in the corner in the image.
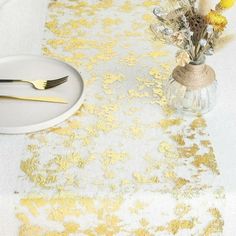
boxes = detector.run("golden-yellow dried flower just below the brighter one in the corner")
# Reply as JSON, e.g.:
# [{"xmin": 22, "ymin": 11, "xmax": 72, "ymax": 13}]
[{"xmin": 206, "ymin": 10, "xmax": 228, "ymax": 32}]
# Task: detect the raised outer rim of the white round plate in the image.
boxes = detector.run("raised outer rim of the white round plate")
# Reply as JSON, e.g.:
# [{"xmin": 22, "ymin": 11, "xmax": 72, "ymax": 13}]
[{"xmin": 0, "ymin": 54, "xmax": 85, "ymax": 135}]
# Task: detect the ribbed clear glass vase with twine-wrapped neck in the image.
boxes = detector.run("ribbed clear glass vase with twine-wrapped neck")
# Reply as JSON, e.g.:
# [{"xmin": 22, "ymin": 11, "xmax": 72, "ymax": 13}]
[{"xmin": 164, "ymin": 63, "xmax": 217, "ymax": 115}]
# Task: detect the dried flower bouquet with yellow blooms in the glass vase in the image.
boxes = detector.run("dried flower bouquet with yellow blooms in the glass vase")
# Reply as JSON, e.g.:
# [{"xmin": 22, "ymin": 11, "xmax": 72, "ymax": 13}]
[{"xmin": 151, "ymin": 0, "xmax": 236, "ymax": 66}]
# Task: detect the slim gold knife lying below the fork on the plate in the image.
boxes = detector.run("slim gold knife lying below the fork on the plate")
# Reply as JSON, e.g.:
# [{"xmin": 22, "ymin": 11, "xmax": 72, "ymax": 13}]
[{"xmin": 0, "ymin": 95, "xmax": 67, "ymax": 104}]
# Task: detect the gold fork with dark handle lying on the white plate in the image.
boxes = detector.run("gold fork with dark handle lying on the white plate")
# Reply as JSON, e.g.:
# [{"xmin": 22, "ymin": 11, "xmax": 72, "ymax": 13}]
[{"xmin": 0, "ymin": 76, "xmax": 69, "ymax": 90}]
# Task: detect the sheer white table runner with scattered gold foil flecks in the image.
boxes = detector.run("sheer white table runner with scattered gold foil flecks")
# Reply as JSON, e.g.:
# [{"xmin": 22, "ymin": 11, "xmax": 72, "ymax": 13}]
[{"xmin": 15, "ymin": 0, "xmax": 224, "ymax": 236}]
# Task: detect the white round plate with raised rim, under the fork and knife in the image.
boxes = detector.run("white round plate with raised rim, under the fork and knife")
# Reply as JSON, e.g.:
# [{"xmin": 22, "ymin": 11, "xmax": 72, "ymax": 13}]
[{"xmin": 0, "ymin": 55, "xmax": 84, "ymax": 134}]
